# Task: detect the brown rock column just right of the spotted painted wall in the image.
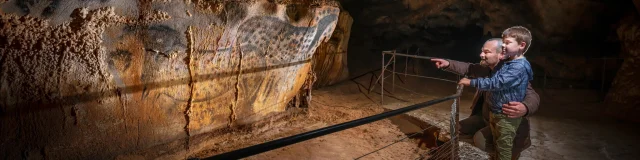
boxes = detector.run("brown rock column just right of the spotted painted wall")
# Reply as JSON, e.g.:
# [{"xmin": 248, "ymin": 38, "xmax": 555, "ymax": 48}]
[{"xmin": 313, "ymin": 8, "xmax": 353, "ymax": 87}]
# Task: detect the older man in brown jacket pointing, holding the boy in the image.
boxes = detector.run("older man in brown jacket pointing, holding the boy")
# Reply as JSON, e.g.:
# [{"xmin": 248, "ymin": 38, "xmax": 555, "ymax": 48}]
[{"xmin": 431, "ymin": 38, "xmax": 540, "ymax": 159}]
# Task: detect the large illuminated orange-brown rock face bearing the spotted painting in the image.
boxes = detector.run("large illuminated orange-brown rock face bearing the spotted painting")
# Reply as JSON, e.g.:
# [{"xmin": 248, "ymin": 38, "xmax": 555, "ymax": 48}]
[{"xmin": 0, "ymin": 0, "xmax": 340, "ymax": 159}]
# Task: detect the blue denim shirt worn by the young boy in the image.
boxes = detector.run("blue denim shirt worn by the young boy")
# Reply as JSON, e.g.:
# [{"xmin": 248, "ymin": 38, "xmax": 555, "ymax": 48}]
[{"xmin": 471, "ymin": 57, "xmax": 533, "ymax": 113}]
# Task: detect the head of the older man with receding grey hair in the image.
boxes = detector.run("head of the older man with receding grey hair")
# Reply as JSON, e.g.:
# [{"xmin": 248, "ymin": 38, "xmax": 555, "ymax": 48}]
[{"xmin": 480, "ymin": 38, "xmax": 502, "ymax": 68}]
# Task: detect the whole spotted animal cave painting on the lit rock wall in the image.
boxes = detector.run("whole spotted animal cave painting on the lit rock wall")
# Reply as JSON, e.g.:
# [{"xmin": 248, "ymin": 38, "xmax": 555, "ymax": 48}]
[{"xmin": 105, "ymin": 2, "xmax": 339, "ymax": 135}]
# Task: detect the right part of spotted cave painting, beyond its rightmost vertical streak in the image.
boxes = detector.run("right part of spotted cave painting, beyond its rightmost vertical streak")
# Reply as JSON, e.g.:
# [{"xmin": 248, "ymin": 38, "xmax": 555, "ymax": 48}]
[{"xmin": 222, "ymin": 9, "xmax": 338, "ymax": 125}]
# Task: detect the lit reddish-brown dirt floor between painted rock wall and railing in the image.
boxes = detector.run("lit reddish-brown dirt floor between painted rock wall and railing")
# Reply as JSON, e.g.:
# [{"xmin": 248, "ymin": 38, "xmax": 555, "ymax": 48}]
[{"xmin": 185, "ymin": 77, "xmax": 442, "ymax": 159}]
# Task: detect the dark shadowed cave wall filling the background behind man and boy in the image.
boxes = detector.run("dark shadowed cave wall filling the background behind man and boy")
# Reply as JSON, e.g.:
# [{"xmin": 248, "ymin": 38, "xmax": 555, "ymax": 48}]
[{"xmin": 342, "ymin": 0, "xmax": 640, "ymax": 122}]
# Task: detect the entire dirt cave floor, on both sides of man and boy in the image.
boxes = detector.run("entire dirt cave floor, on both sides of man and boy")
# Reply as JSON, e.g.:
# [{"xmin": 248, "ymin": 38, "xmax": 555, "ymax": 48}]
[{"xmin": 175, "ymin": 72, "xmax": 640, "ymax": 159}]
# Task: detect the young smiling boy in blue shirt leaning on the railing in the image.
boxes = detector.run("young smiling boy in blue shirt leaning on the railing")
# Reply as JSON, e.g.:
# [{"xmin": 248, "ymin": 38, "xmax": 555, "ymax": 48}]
[{"xmin": 460, "ymin": 26, "xmax": 533, "ymax": 160}]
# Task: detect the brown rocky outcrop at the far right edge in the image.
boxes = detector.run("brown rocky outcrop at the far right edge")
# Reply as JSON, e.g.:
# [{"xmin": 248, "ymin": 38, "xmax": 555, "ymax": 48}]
[{"xmin": 606, "ymin": 12, "xmax": 640, "ymax": 122}]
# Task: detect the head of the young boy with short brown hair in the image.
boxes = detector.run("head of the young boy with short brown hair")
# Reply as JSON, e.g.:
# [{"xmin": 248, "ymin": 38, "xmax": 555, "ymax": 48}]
[{"xmin": 502, "ymin": 26, "xmax": 532, "ymax": 58}]
